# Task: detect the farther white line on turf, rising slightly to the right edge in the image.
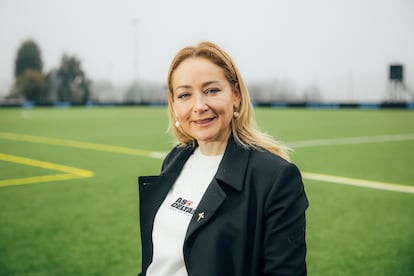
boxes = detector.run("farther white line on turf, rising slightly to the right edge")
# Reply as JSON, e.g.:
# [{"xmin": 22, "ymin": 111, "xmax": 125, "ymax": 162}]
[{"xmin": 287, "ymin": 133, "xmax": 414, "ymax": 149}]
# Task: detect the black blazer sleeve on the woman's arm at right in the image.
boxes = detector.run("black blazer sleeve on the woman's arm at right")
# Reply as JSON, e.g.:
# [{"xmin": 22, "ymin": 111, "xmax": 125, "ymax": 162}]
[{"xmin": 263, "ymin": 164, "xmax": 309, "ymax": 275}]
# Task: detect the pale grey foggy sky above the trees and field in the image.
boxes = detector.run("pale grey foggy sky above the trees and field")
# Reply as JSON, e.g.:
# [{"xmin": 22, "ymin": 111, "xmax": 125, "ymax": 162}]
[{"xmin": 0, "ymin": 0, "xmax": 414, "ymax": 102}]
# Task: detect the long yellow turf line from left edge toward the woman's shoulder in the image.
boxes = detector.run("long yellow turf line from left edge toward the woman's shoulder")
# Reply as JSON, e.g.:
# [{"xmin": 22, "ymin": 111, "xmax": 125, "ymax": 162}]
[{"xmin": 0, "ymin": 132, "xmax": 164, "ymax": 157}]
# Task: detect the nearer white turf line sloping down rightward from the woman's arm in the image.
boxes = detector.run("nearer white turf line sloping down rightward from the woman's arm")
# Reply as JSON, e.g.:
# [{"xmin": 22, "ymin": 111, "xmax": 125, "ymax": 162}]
[{"xmin": 302, "ymin": 172, "xmax": 414, "ymax": 194}]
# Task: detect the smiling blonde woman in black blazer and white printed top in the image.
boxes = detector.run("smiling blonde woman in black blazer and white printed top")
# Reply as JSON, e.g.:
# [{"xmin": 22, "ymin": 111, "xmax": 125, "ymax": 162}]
[{"xmin": 139, "ymin": 42, "xmax": 308, "ymax": 276}]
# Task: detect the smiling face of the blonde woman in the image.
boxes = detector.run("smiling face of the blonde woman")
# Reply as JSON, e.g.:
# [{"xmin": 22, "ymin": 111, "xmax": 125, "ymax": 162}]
[{"xmin": 172, "ymin": 57, "xmax": 240, "ymax": 149}]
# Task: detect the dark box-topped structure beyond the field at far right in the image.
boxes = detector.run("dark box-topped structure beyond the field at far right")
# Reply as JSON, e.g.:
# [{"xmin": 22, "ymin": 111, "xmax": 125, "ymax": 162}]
[{"xmin": 388, "ymin": 64, "xmax": 414, "ymax": 102}]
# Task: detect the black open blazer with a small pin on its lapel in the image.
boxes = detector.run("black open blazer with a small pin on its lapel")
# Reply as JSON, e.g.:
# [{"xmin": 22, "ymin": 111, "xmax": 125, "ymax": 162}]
[{"xmin": 139, "ymin": 137, "xmax": 308, "ymax": 276}]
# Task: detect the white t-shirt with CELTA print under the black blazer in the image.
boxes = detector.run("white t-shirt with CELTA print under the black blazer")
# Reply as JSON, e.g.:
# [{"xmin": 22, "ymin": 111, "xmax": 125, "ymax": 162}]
[{"xmin": 147, "ymin": 148, "xmax": 223, "ymax": 276}]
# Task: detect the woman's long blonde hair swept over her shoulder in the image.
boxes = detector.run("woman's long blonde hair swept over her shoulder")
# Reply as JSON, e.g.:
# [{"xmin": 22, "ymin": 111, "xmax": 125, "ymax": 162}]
[{"xmin": 168, "ymin": 42, "xmax": 289, "ymax": 160}]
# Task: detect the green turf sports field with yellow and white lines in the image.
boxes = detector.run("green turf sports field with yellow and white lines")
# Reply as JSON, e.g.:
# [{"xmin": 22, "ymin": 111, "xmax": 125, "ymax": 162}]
[{"xmin": 0, "ymin": 107, "xmax": 414, "ymax": 275}]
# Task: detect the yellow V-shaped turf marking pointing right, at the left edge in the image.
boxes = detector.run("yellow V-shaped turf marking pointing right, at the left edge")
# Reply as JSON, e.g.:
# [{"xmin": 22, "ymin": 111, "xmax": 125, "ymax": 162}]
[{"xmin": 0, "ymin": 153, "xmax": 94, "ymax": 187}]
